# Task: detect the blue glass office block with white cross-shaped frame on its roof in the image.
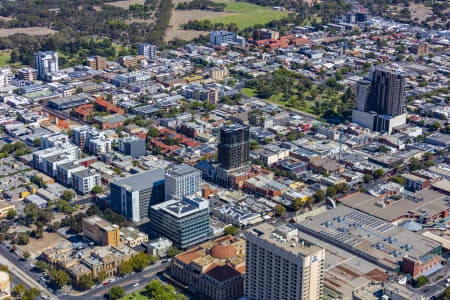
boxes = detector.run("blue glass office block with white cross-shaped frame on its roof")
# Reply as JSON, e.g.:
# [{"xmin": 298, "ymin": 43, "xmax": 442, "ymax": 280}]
[{"xmin": 150, "ymin": 197, "xmax": 212, "ymax": 249}]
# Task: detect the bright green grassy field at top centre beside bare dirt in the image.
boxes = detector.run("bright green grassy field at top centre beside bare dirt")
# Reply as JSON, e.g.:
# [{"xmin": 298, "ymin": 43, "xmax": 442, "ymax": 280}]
[{"xmin": 211, "ymin": 2, "xmax": 288, "ymax": 29}]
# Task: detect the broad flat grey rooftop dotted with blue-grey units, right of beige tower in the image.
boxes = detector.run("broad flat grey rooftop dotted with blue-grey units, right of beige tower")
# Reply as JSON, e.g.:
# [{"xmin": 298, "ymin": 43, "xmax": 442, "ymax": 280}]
[{"xmin": 298, "ymin": 206, "xmax": 440, "ymax": 269}]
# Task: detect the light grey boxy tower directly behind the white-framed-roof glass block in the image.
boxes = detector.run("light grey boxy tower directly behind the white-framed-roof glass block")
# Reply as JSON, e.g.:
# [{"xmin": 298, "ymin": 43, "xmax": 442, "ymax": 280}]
[{"xmin": 165, "ymin": 164, "xmax": 202, "ymax": 200}]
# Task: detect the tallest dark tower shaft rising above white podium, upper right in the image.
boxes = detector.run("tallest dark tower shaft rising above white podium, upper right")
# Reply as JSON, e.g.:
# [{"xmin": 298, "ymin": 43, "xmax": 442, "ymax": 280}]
[{"xmin": 368, "ymin": 67, "xmax": 406, "ymax": 117}]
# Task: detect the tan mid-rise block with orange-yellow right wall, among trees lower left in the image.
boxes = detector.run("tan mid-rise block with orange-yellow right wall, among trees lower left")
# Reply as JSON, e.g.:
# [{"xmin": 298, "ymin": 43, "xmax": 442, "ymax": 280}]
[{"xmin": 82, "ymin": 216, "xmax": 120, "ymax": 247}]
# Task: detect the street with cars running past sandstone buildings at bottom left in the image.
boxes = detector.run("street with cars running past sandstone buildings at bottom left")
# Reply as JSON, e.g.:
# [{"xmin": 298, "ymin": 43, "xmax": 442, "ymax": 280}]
[{"xmin": 53, "ymin": 263, "xmax": 169, "ymax": 300}]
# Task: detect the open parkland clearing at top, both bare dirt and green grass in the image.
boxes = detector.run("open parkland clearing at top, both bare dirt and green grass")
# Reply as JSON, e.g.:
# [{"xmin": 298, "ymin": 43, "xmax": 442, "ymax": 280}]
[{"xmin": 165, "ymin": 0, "xmax": 287, "ymax": 41}]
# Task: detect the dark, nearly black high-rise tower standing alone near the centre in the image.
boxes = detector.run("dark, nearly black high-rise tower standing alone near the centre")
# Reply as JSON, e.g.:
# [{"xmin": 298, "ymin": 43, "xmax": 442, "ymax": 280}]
[{"xmin": 218, "ymin": 124, "xmax": 249, "ymax": 170}]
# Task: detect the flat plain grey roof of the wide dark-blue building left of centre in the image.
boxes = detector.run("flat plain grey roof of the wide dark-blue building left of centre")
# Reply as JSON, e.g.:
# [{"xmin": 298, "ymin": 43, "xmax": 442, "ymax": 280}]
[{"xmin": 113, "ymin": 169, "xmax": 164, "ymax": 192}]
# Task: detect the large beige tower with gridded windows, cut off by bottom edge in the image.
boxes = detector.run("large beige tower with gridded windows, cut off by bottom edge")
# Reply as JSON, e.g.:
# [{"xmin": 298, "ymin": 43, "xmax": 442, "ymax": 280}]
[{"xmin": 245, "ymin": 223, "xmax": 325, "ymax": 300}]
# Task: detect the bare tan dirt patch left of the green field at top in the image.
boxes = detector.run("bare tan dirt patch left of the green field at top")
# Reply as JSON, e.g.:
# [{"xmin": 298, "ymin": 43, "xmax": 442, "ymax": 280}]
[{"xmin": 164, "ymin": 8, "xmax": 233, "ymax": 42}]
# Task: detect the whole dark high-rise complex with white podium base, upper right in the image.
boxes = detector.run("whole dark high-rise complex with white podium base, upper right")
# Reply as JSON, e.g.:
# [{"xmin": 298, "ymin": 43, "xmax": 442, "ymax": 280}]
[{"xmin": 352, "ymin": 66, "xmax": 406, "ymax": 134}]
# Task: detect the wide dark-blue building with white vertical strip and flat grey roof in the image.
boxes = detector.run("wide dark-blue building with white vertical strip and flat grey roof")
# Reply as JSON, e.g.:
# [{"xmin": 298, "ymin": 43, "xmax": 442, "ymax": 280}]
[{"xmin": 110, "ymin": 169, "xmax": 164, "ymax": 222}]
